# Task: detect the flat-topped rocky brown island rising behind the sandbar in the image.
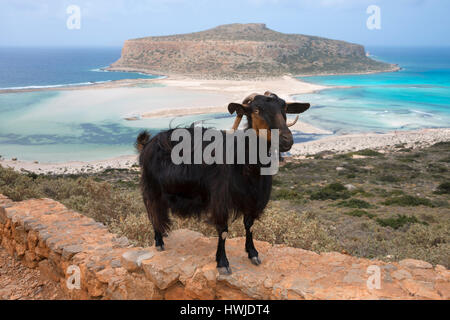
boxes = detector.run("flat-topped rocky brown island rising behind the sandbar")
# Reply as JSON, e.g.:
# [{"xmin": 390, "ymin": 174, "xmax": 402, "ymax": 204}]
[{"xmin": 109, "ymin": 24, "xmax": 398, "ymax": 79}]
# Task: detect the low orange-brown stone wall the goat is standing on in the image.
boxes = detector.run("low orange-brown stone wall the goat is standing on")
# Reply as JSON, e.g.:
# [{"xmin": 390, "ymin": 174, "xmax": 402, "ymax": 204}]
[{"xmin": 0, "ymin": 195, "xmax": 450, "ymax": 299}]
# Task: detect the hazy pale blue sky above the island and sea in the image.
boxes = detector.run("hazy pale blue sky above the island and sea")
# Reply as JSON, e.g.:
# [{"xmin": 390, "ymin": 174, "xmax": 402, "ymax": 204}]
[{"xmin": 0, "ymin": 0, "xmax": 450, "ymax": 47}]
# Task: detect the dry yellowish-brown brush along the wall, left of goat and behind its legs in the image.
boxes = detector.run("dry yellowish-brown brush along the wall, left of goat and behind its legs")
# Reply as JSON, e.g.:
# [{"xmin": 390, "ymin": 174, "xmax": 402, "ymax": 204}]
[{"xmin": 0, "ymin": 167, "xmax": 337, "ymax": 251}]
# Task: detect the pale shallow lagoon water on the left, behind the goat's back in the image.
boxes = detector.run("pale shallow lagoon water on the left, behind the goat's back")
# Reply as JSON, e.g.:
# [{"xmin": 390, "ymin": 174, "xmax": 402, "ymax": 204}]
[{"xmin": 0, "ymin": 87, "xmax": 239, "ymax": 162}]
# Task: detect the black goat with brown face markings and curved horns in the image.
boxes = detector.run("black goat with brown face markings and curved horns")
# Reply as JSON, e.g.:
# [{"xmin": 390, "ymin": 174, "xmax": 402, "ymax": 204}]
[{"xmin": 136, "ymin": 92, "xmax": 309, "ymax": 274}]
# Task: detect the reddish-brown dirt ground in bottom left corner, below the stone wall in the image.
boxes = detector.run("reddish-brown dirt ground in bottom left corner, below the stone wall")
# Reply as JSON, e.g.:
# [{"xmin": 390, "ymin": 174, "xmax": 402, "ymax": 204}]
[{"xmin": 0, "ymin": 247, "xmax": 67, "ymax": 300}]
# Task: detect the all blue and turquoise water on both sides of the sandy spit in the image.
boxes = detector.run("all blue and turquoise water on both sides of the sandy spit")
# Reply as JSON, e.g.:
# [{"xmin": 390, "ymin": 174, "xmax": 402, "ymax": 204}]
[{"xmin": 0, "ymin": 48, "xmax": 450, "ymax": 162}]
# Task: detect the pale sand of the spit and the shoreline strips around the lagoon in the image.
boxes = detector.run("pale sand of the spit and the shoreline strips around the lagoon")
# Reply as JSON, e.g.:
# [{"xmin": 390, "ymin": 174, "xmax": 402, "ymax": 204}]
[{"xmin": 0, "ymin": 76, "xmax": 450, "ymax": 174}]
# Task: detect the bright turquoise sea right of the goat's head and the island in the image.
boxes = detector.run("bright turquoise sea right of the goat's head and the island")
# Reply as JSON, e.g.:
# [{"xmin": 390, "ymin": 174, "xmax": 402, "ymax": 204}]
[{"xmin": 296, "ymin": 47, "xmax": 450, "ymax": 134}]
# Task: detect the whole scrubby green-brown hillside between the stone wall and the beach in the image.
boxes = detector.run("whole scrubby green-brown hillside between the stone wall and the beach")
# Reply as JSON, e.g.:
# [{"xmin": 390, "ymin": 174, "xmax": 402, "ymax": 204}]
[{"xmin": 0, "ymin": 142, "xmax": 450, "ymax": 268}]
